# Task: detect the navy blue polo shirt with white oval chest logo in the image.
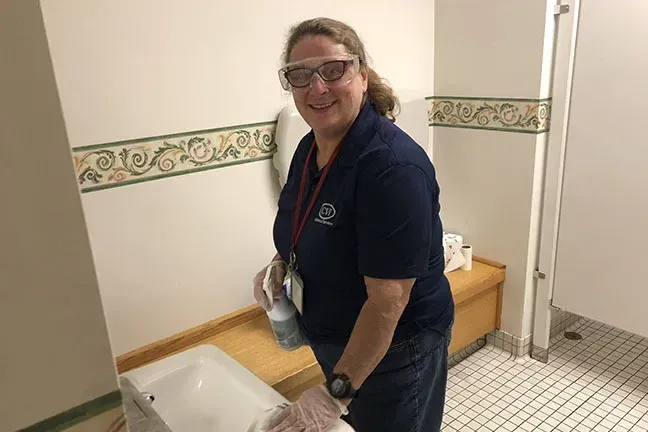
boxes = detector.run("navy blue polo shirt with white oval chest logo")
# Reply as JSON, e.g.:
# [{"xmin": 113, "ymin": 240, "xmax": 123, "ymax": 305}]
[{"xmin": 274, "ymin": 103, "xmax": 454, "ymax": 344}]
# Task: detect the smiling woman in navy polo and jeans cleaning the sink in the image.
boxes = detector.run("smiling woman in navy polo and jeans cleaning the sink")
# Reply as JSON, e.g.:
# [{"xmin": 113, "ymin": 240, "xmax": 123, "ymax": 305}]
[{"xmin": 255, "ymin": 18, "xmax": 454, "ymax": 432}]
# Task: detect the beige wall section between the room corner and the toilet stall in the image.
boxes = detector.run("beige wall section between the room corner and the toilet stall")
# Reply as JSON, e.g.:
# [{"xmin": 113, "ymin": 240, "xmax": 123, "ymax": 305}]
[{"xmin": 434, "ymin": 0, "xmax": 553, "ymax": 337}]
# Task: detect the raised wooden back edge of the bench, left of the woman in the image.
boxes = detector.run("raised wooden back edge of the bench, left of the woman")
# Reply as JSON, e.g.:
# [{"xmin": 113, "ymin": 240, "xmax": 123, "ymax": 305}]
[{"xmin": 116, "ymin": 304, "xmax": 264, "ymax": 374}]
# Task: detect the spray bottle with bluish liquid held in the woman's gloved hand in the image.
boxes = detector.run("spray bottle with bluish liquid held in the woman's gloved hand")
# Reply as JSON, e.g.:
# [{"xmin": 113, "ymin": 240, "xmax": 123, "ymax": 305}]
[{"xmin": 263, "ymin": 261, "xmax": 304, "ymax": 351}]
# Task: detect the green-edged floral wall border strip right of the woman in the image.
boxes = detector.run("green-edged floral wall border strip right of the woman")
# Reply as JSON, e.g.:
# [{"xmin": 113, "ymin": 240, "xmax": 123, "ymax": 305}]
[{"xmin": 426, "ymin": 96, "xmax": 551, "ymax": 134}]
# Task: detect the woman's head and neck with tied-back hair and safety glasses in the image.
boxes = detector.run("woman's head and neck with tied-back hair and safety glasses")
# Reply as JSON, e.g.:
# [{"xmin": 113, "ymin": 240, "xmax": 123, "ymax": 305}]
[{"xmin": 279, "ymin": 18, "xmax": 398, "ymax": 170}]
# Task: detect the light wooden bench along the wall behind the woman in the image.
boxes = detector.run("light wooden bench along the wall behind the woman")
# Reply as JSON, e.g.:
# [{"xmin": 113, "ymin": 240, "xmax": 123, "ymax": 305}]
[{"xmin": 117, "ymin": 257, "xmax": 505, "ymax": 401}]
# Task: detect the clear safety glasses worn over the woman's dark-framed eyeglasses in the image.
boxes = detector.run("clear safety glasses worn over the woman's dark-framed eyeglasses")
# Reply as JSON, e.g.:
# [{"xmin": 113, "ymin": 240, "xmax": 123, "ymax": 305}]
[{"xmin": 279, "ymin": 56, "xmax": 360, "ymax": 90}]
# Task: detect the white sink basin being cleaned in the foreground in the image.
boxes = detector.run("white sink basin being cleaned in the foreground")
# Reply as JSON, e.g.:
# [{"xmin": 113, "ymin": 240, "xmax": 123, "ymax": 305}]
[{"xmin": 123, "ymin": 345, "xmax": 350, "ymax": 432}]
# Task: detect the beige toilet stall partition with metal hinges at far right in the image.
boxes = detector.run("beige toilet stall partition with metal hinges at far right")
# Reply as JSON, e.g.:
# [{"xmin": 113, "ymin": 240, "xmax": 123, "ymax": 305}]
[{"xmin": 533, "ymin": 0, "xmax": 648, "ymax": 361}]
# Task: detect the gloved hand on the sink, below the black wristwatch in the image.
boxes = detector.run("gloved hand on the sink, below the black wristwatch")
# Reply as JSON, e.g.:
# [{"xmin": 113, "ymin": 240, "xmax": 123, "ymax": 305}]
[{"xmin": 267, "ymin": 385, "xmax": 348, "ymax": 432}]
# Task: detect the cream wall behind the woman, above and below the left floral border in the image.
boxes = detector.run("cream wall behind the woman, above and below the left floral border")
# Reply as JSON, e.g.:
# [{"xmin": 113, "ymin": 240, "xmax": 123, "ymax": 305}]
[{"xmin": 44, "ymin": 0, "xmax": 433, "ymax": 354}]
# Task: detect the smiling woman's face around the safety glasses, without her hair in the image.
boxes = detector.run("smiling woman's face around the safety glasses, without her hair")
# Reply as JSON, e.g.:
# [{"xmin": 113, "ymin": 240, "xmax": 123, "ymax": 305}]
[{"xmin": 289, "ymin": 36, "xmax": 367, "ymax": 138}]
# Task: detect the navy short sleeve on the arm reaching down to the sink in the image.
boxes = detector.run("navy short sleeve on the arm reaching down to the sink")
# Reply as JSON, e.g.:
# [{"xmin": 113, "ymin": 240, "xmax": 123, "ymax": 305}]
[{"xmin": 356, "ymin": 165, "xmax": 434, "ymax": 279}]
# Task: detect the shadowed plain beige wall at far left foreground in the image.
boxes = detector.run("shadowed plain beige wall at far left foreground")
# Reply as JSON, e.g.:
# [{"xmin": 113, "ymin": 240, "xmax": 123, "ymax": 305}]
[{"xmin": 0, "ymin": 0, "xmax": 117, "ymax": 431}]
